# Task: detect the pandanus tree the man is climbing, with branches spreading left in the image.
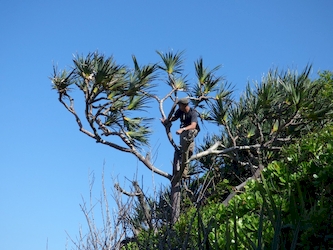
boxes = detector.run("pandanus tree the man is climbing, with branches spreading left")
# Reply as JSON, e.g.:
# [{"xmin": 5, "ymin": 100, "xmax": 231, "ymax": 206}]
[{"xmin": 52, "ymin": 52, "xmax": 231, "ymax": 230}]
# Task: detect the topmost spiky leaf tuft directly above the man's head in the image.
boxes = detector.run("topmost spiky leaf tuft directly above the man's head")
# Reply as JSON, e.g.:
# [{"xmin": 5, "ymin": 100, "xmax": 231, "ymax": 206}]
[{"xmin": 156, "ymin": 51, "xmax": 184, "ymax": 75}]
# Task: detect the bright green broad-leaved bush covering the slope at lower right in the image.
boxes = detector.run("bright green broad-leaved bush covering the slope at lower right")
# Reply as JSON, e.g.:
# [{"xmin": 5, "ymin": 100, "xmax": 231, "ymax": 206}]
[{"xmin": 166, "ymin": 126, "xmax": 333, "ymax": 249}]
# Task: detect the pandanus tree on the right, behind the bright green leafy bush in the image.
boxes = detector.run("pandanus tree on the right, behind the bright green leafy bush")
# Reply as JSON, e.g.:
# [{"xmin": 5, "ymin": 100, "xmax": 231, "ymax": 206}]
[{"xmin": 189, "ymin": 66, "xmax": 332, "ymax": 205}]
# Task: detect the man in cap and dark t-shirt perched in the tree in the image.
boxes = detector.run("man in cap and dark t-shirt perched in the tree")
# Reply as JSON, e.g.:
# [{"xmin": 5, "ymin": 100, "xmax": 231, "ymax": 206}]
[{"xmin": 161, "ymin": 97, "xmax": 200, "ymax": 178}]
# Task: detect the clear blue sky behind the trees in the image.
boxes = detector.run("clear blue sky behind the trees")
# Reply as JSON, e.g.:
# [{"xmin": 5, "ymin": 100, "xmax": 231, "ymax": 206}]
[{"xmin": 0, "ymin": 0, "xmax": 333, "ymax": 250}]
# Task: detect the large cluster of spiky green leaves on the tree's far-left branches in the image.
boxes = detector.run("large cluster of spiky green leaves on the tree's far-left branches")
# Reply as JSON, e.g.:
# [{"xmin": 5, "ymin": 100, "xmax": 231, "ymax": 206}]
[{"xmin": 52, "ymin": 52, "xmax": 157, "ymax": 146}]
